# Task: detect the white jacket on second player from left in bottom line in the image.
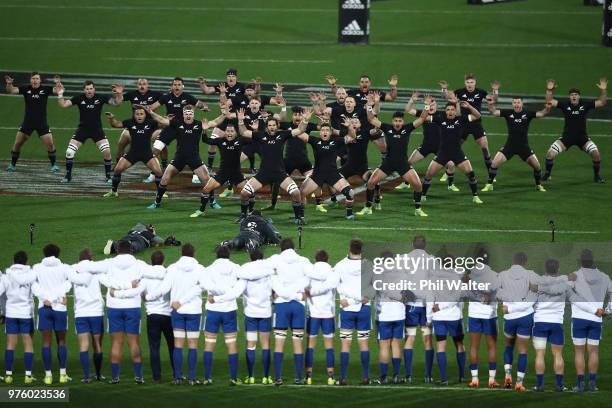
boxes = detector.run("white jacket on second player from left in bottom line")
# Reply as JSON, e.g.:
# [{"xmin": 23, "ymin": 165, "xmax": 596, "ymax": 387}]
[{"xmin": 32, "ymin": 256, "xmax": 71, "ymax": 312}]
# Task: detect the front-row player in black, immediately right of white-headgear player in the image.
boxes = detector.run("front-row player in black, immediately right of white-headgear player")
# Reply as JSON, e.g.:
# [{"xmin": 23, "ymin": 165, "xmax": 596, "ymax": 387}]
[{"xmin": 190, "ymin": 123, "xmax": 254, "ymax": 218}]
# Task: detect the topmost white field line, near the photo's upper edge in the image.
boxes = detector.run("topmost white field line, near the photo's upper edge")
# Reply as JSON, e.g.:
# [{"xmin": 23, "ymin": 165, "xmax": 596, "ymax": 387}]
[{"xmin": 0, "ymin": 4, "xmax": 601, "ymax": 16}]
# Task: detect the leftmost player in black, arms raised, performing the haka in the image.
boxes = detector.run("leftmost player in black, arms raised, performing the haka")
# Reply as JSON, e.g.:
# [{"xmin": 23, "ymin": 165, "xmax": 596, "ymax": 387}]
[{"xmin": 4, "ymin": 72, "xmax": 60, "ymax": 173}]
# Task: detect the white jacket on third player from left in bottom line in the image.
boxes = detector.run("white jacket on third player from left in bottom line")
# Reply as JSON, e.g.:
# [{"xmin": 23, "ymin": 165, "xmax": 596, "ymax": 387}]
[{"xmin": 68, "ymin": 260, "xmax": 104, "ymax": 317}]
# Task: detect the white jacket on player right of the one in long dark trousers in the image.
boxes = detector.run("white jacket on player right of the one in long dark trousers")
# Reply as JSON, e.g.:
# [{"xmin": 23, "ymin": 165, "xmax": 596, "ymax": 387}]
[{"xmin": 146, "ymin": 256, "xmax": 206, "ymax": 314}]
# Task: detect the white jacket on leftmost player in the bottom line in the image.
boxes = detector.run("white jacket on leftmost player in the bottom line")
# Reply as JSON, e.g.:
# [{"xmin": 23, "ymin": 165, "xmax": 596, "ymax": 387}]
[{"xmin": 4, "ymin": 264, "xmax": 36, "ymax": 319}]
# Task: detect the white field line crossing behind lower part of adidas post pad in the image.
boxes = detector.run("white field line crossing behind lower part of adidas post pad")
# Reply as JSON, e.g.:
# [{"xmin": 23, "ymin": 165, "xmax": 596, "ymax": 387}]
[{"xmin": 0, "ymin": 37, "xmax": 601, "ymax": 48}]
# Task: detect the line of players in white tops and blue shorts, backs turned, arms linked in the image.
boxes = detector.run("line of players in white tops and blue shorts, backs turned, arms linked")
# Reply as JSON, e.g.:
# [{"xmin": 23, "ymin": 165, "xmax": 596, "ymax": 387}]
[{"xmin": 0, "ymin": 236, "xmax": 612, "ymax": 391}]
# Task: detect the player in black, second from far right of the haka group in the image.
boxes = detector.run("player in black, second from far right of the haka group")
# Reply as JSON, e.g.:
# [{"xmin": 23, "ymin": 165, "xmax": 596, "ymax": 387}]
[{"xmin": 481, "ymin": 86, "xmax": 551, "ymax": 191}]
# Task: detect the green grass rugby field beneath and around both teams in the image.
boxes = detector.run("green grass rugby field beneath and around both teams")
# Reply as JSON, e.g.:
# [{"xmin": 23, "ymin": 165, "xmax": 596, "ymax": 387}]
[{"xmin": 0, "ymin": 0, "xmax": 612, "ymax": 407}]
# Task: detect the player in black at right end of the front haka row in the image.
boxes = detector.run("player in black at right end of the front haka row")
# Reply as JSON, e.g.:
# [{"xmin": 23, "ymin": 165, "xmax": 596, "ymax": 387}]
[{"xmin": 422, "ymin": 95, "xmax": 482, "ymax": 204}]
